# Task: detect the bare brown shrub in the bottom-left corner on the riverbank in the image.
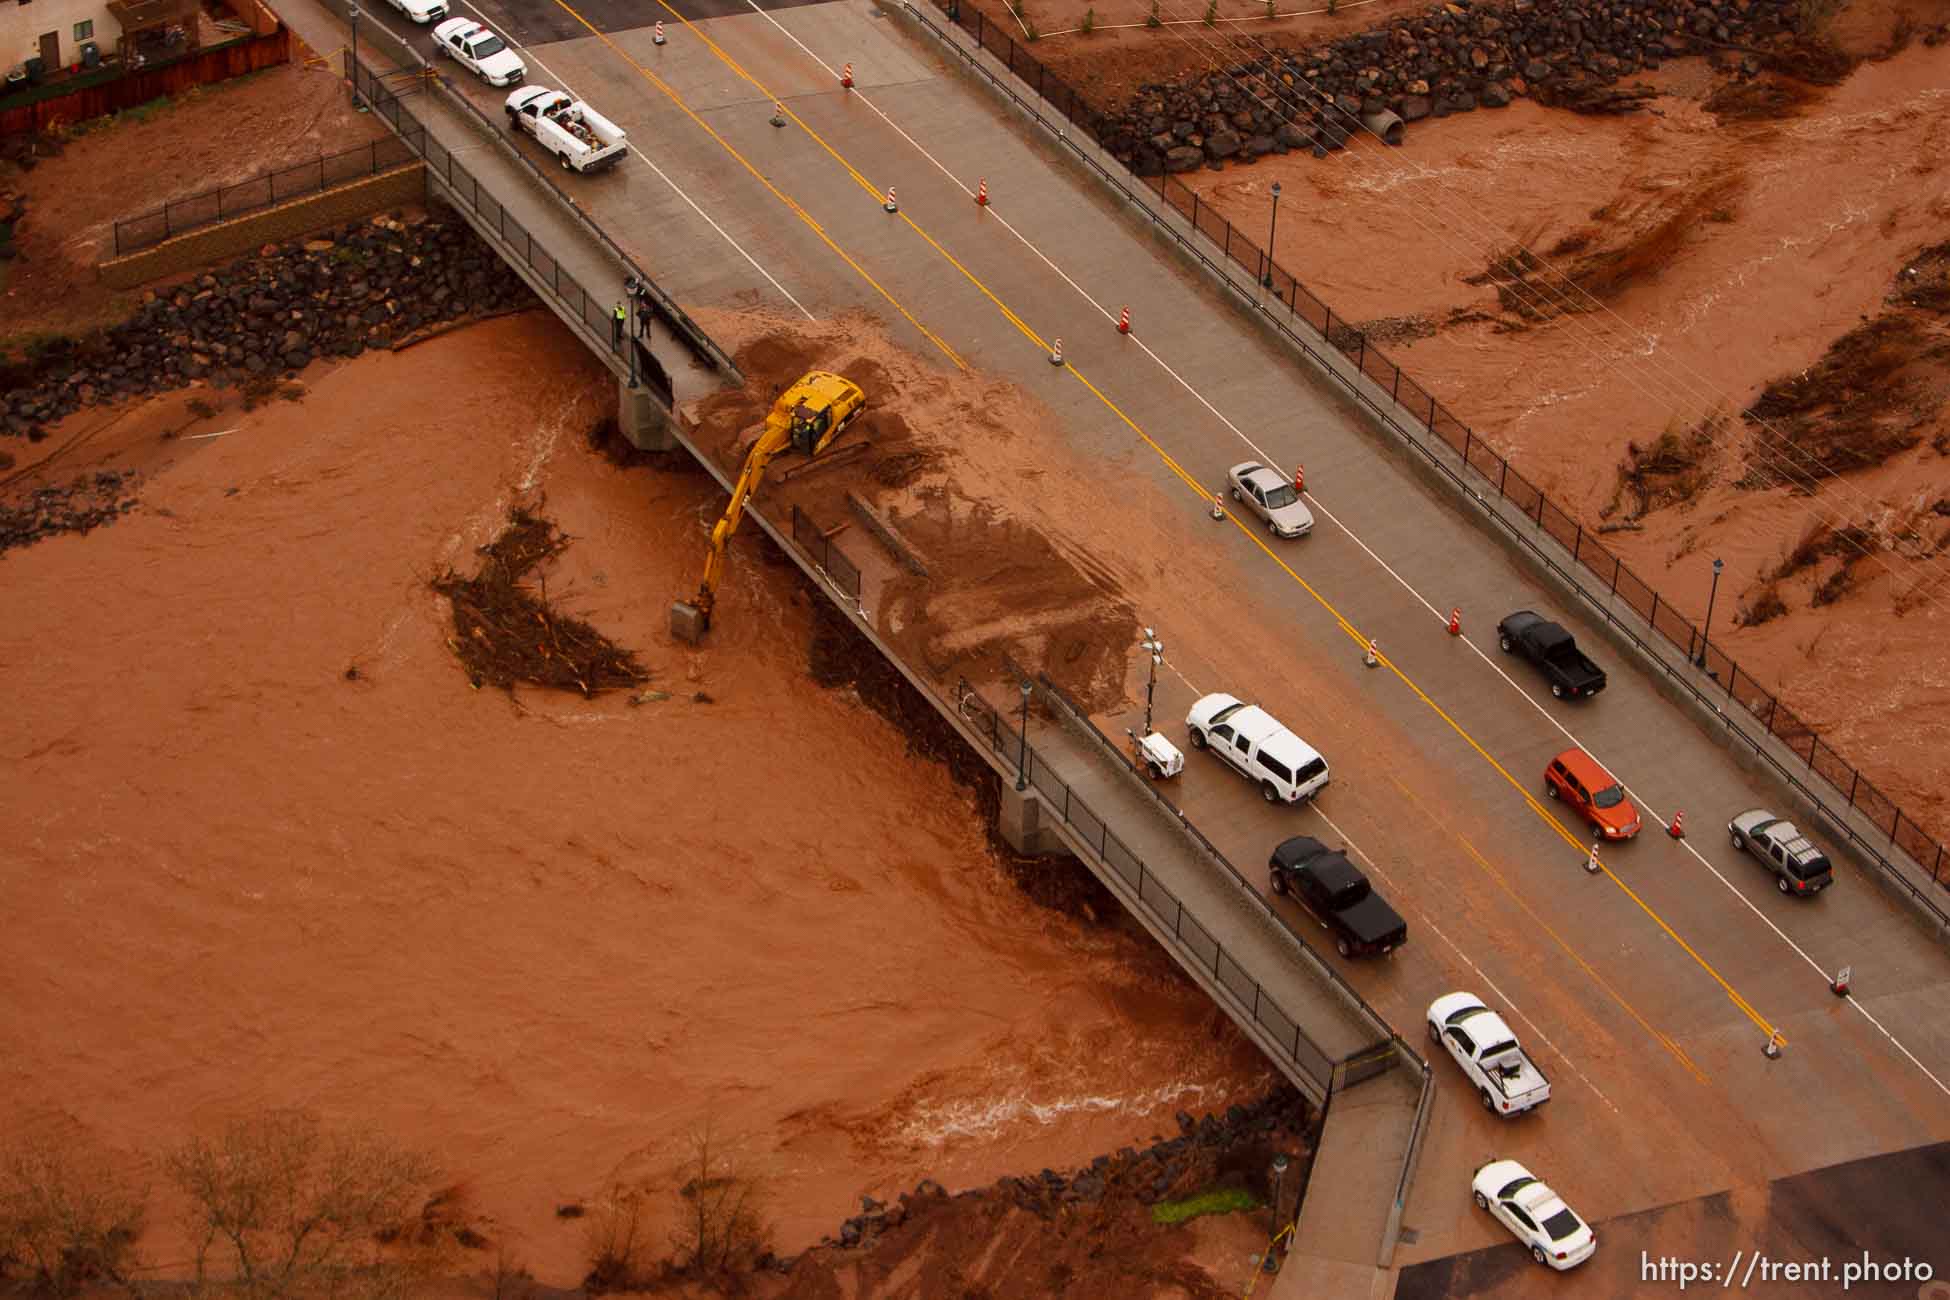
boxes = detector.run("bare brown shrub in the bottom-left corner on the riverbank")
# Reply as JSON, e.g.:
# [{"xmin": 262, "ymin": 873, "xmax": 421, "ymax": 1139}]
[{"xmin": 0, "ymin": 1132, "xmax": 146, "ymax": 1296}]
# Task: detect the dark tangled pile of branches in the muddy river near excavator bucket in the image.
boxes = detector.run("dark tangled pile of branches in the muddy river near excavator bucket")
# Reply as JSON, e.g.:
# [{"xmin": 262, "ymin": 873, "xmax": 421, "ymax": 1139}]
[{"xmin": 433, "ymin": 509, "xmax": 649, "ymax": 698}]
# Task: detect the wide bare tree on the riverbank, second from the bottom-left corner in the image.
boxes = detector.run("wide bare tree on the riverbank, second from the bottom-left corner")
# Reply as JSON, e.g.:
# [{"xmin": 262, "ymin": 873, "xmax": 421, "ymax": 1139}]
[{"xmin": 168, "ymin": 1109, "xmax": 433, "ymax": 1296}]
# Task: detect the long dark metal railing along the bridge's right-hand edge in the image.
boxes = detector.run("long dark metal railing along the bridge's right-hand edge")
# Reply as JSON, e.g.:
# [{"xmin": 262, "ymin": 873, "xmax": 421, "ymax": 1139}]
[{"xmin": 899, "ymin": 0, "xmax": 1950, "ymax": 928}]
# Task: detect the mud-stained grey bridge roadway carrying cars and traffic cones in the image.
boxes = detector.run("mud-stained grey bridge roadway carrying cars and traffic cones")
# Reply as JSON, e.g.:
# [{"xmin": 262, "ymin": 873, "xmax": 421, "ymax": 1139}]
[{"xmin": 331, "ymin": 0, "xmax": 1950, "ymax": 1259}]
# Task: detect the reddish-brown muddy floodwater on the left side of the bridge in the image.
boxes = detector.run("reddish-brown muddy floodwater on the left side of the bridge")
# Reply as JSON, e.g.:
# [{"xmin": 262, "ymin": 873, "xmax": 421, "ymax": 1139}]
[{"xmin": 0, "ymin": 316, "xmax": 1269, "ymax": 1294}]
